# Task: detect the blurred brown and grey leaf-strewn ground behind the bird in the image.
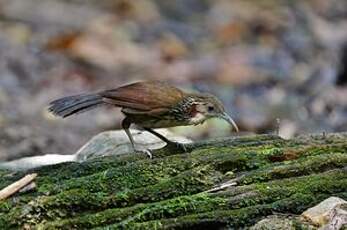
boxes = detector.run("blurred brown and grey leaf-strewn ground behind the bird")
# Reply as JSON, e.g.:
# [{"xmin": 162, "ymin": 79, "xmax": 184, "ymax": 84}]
[{"xmin": 0, "ymin": 0, "xmax": 347, "ymax": 161}]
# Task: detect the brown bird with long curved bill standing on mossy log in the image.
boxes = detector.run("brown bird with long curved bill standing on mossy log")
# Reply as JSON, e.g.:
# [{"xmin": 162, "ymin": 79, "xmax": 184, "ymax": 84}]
[{"xmin": 48, "ymin": 81, "xmax": 239, "ymax": 158}]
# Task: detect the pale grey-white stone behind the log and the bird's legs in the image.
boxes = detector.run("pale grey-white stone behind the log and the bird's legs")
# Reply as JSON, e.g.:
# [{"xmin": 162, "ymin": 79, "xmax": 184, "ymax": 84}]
[{"xmin": 0, "ymin": 129, "xmax": 192, "ymax": 171}]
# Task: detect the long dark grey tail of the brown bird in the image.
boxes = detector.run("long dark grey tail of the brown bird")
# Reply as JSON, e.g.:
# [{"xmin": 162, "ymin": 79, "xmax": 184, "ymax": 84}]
[{"xmin": 48, "ymin": 94, "xmax": 104, "ymax": 117}]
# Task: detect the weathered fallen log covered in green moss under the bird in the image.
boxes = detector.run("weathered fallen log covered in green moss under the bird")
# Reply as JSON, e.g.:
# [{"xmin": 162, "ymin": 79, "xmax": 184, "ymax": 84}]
[{"xmin": 0, "ymin": 133, "xmax": 347, "ymax": 229}]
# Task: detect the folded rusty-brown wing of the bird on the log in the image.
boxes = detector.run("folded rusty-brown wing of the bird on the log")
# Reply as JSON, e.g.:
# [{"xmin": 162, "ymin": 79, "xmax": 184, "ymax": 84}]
[{"xmin": 99, "ymin": 81, "xmax": 184, "ymax": 112}]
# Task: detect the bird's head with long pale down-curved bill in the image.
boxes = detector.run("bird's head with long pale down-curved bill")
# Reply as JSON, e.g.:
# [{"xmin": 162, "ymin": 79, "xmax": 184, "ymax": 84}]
[{"xmin": 190, "ymin": 94, "xmax": 239, "ymax": 132}]
